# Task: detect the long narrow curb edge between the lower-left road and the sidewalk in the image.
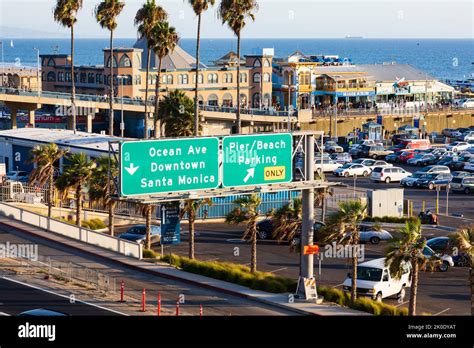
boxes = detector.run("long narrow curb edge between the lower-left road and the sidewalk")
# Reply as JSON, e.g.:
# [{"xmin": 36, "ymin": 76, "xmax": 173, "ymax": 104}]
[{"xmin": 0, "ymin": 221, "xmax": 320, "ymax": 316}]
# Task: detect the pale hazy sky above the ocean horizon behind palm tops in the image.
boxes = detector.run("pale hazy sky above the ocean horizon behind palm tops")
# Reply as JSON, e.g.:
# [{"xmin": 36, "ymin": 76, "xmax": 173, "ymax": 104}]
[{"xmin": 0, "ymin": 0, "xmax": 474, "ymax": 38}]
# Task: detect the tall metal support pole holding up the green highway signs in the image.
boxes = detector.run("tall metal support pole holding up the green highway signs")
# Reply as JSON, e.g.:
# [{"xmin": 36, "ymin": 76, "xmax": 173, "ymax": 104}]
[{"xmin": 298, "ymin": 134, "xmax": 314, "ymax": 295}]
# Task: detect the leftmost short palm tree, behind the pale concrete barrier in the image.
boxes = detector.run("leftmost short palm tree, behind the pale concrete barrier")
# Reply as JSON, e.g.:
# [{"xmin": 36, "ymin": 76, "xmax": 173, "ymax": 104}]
[{"xmin": 30, "ymin": 143, "xmax": 69, "ymax": 218}]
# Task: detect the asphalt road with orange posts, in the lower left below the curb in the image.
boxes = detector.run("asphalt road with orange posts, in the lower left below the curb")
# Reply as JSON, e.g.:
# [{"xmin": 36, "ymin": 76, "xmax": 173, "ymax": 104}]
[{"xmin": 0, "ymin": 225, "xmax": 297, "ymax": 316}]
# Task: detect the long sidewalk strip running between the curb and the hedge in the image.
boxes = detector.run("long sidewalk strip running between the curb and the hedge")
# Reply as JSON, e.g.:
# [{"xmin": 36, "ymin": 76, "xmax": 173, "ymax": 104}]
[{"xmin": 0, "ymin": 217, "xmax": 370, "ymax": 315}]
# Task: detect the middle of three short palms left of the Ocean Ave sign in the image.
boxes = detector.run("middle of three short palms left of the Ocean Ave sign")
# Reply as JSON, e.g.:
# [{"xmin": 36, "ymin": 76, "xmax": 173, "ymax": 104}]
[{"xmin": 56, "ymin": 152, "xmax": 95, "ymax": 226}]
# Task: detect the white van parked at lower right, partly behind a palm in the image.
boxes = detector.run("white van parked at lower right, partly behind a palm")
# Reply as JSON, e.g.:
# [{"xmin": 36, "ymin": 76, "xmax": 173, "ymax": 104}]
[{"xmin": 343, "ymin": 258, "xmax": 411, "ymax": 302}]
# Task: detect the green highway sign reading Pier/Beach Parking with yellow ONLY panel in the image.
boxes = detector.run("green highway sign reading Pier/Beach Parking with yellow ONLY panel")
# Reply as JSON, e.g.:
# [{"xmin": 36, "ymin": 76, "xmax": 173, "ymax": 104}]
[{"xmin": 222, "ymin": 133, "xmax": 293, "ymax": 187}]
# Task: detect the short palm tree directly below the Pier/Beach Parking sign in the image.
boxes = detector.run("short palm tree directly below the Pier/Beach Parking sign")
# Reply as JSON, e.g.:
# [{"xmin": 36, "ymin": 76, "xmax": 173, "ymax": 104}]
[{"xmin": 225, "ymin": 194, "xmax": 262, "ymax": 273}]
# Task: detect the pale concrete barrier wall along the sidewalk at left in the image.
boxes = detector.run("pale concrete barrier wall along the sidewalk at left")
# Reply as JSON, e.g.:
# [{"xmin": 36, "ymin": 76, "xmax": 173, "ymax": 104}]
[{"xmin": 0, "ymin": 203, "xmax": 143, "ymax": 259}]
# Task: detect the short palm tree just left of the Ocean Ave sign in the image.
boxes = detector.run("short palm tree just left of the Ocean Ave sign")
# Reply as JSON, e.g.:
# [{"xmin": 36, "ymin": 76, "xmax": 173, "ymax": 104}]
[{"xmin": 89, "ymin": 156, "xmax": 119, "ymax": 236}]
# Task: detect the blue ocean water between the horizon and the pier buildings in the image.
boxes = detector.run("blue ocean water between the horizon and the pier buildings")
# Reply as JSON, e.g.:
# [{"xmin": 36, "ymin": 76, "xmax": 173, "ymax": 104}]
[{"xmin": 1, "ymin": 38, "xmax": 474, "ymax": 80}]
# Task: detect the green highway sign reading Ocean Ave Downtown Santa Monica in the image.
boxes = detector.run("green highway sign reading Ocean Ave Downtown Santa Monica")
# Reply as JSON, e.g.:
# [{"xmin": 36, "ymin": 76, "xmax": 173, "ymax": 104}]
[{"xmin": 120, "ymin": 138, "xmax": 219, "ymax": 196}]
